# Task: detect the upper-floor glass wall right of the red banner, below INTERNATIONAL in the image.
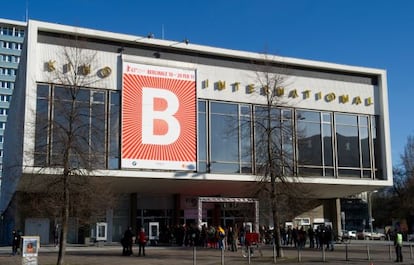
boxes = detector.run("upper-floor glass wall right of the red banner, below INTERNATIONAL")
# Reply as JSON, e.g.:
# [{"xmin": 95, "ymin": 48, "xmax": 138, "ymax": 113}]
[{"xmin": 198, "ymin": 100, "xmax": 384, "ymax": 179}]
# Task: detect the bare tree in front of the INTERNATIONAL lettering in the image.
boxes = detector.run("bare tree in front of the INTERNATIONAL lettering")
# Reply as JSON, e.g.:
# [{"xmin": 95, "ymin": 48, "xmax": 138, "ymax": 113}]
[{"xmin": 249, "ymin": 58, "xmax": 311, "ymax": 257}]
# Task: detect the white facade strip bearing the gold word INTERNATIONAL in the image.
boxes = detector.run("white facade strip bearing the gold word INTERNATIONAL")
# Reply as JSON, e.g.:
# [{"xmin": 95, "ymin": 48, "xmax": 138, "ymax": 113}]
[{"xmin": 197, "ymin": 65, "xmax": 379, "ymax": 114}]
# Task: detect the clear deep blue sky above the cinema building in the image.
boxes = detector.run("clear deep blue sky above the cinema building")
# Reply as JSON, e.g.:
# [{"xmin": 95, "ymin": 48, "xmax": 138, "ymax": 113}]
[{"xmin": 0, "ymin": 0, "xmax": 414, "ymax": 165}]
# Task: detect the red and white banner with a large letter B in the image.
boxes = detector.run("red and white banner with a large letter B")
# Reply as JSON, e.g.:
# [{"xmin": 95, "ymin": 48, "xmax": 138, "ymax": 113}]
[{"xmin": 121, "ymin": 62, "xmax": 197, "ymax": 171}]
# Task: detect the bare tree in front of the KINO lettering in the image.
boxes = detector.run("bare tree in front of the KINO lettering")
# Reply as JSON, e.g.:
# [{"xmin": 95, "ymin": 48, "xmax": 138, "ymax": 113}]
[{"xmin": 23, "ymin": 39, "xmax": 114, "ymax": 265}]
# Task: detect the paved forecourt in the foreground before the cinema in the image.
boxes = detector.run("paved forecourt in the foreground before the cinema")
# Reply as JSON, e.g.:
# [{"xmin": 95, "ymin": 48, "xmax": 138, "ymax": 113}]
[{"xmin": 0, "ymin": 242, "xmax": 414, "ymax": 265}]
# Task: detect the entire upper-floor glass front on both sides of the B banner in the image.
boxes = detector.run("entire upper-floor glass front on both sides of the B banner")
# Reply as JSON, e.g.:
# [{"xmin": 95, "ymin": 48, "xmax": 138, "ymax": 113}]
[{"xmin": 34, "ymin": 91, "xmax": 384, "ymax": 179}]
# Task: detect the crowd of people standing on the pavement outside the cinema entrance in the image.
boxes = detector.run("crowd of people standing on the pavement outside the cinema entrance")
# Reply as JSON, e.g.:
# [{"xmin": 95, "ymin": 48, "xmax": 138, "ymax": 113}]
[{"xmin": 119, "ymin": 224, "xmax": 335, "ymax": 255}]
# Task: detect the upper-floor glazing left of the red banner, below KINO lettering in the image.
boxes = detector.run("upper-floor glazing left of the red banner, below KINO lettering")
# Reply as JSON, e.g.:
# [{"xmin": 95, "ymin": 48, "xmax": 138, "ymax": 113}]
[{"xmin": 35, "ymin": 84, "xmax": 119, "ymax": 169}]
